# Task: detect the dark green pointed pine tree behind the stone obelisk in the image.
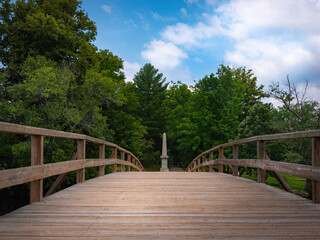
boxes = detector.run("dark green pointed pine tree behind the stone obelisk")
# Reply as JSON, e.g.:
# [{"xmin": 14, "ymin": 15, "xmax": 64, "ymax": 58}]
[{"xmin": 133, "ymin": 63, "xmax": 168, "ymax": 160}]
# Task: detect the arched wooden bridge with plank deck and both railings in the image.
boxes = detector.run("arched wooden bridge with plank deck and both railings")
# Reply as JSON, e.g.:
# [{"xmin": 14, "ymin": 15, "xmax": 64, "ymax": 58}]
[{"xmin": 0, "ymin": 123, "xmax": 320, "ymax": 239}]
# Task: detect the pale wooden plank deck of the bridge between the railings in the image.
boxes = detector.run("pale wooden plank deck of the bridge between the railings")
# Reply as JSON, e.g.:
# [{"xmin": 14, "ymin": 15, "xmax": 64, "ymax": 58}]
[{"xmin": 0, "ymin": 172, "xmax": 320, "ymax": 239}]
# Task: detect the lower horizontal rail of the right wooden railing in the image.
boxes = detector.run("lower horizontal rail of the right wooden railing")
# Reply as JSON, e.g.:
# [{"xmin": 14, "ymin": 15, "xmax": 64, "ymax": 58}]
[{"xmin": 202, "ymin": 159, "xmax": 320, "ymax": 181}]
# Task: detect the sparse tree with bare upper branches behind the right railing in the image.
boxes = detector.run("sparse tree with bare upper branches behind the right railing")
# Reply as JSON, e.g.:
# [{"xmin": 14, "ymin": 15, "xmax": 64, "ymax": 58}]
[{"xmin": 270, "ymin": 77, "xmax": 320, "ymax": 192}]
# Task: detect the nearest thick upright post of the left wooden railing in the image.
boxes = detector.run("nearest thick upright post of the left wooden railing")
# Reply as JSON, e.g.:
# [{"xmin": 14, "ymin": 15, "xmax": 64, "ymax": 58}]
[{"xmin": 30, "ymin": 135, "xmax": 43, "ymax": 203}]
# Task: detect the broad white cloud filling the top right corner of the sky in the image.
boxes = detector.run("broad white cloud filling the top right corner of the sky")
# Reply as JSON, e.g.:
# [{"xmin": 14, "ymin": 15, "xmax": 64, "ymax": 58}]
[{"xmin": 216, "ymin": 0, "xmax": 320, "ymax": 37}]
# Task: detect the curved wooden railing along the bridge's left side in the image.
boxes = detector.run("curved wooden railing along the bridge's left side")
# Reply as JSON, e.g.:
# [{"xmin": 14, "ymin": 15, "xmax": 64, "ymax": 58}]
[{"xmin": 0, "ymin": 122, "xmax": 144, "ymax": 203}]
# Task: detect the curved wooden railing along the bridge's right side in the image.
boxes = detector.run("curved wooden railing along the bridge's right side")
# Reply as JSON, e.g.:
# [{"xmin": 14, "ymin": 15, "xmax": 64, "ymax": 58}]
[{"xmin": 186, "ymin": 130, "xmax": 320, "ymax": 204}]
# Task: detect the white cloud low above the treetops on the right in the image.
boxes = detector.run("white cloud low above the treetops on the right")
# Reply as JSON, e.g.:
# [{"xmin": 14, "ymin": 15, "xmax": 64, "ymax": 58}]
[{"xmin": 225, "ymin": 39, "xmax": 314, "ymax": 85}]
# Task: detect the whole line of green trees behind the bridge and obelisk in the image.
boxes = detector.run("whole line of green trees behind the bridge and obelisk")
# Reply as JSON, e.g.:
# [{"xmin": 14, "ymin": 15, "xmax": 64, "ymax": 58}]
[{"xmin": 0, "ymin": 0, "xmax": 320, "ymax": 175}]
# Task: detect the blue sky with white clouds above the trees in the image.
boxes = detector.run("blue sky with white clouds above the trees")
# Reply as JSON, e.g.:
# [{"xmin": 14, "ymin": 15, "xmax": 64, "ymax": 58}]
[{"xmin": 83, "ymin": 0, "xmax": 320, "ymax": 103}]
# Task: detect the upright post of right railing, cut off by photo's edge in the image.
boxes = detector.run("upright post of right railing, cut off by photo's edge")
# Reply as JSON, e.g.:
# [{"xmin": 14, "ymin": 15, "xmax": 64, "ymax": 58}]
[{"xmin": 312, "ymin": 137, "xmax": 320, "ymax": 204}]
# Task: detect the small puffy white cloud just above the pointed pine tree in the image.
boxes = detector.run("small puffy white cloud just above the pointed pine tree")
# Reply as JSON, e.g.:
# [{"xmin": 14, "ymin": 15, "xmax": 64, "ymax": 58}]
[{"xmin": 141, "ymin": 40, "xmax": 188, "ymax": 69}]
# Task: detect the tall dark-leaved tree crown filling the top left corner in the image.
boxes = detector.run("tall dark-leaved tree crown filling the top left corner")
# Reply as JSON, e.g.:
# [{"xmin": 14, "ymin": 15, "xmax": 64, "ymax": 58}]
[{"xmin": 0, "ymin": 0, "xmax": 96, "ymax": 83}]
